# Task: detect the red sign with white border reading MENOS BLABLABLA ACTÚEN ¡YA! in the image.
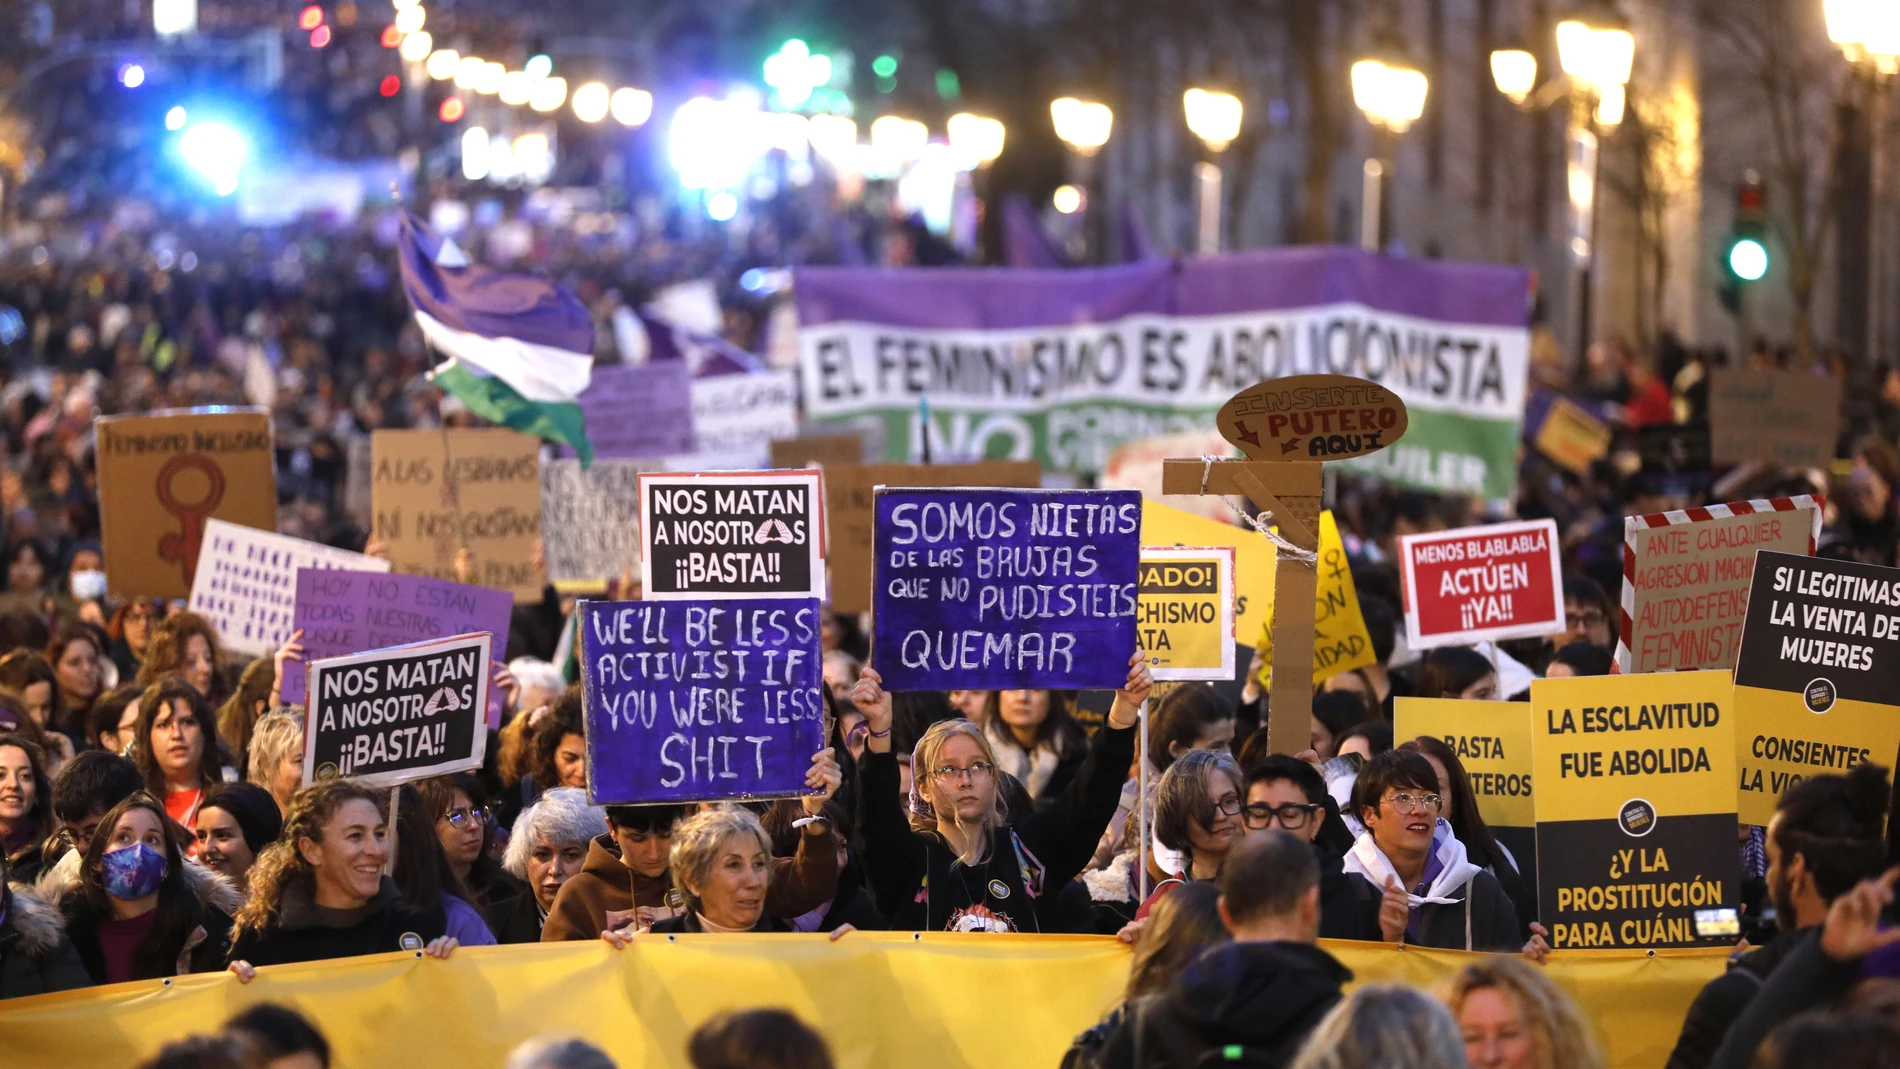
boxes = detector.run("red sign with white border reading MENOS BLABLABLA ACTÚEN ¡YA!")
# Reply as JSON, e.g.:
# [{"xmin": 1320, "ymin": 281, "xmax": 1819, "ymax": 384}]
[{"xmin": 1398, "ymin": 520, "xmax": 1564, "ymax": 649}]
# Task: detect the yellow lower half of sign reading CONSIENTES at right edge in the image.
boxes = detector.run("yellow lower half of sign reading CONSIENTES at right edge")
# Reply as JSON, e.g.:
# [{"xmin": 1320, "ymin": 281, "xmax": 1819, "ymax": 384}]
[{"xmin": 1735, "ymin": 687, "xmax": 1900, "ymax": 826}]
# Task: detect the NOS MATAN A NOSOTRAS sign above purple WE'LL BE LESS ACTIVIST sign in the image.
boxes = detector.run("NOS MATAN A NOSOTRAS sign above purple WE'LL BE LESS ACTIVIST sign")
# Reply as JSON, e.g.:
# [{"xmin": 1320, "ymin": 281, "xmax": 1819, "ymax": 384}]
[{"xmin": 638, "ymin": 471, "xmax": 825, "ymax": 600}]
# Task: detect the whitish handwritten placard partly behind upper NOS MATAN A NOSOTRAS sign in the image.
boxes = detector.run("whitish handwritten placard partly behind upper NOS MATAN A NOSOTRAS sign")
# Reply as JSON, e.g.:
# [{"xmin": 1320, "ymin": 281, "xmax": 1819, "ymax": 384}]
[{"xmin": 542, "ymin": 459, "xmax": 654, "ymax": 589}]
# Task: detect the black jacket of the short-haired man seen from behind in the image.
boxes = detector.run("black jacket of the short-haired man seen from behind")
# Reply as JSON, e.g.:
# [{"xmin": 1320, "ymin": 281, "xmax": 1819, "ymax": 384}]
[{"xmin": 1100, "ymin": 942, "xmax": 1353, "ymax": 1069}]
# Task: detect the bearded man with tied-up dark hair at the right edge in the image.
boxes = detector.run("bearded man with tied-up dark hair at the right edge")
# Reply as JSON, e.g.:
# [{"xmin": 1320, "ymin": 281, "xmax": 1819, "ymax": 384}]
[{"xmin": 1668, "ymin": 763, "xmax": 1889, "ymax": 1069}]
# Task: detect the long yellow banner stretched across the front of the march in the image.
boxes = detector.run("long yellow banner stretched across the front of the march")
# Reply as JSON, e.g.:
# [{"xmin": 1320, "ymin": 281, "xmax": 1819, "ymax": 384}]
[{"xmin": 0, "ymin": 932, "xmax": 1725, "ymax": 1069}]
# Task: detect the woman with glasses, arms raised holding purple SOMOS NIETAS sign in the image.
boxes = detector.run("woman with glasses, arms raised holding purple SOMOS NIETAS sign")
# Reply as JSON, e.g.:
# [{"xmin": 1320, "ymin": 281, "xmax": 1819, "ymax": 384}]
[{"xmin": 851, "ymin": 649, "xmax": 1151, "ymax": 932}]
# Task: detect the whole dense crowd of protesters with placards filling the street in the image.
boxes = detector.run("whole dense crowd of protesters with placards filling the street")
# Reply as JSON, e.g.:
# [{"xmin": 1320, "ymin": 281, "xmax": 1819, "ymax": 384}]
[{"xmin": 18, "ymin": 8, "xmax": 1900, "ymax": 1069}]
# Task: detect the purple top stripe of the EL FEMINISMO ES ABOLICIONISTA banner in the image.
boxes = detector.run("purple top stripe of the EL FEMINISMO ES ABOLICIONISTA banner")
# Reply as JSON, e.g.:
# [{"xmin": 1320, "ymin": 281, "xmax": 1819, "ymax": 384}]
[{"xmin": 792, "ymin": 247, "xmax": 1531, "ymax": 330}]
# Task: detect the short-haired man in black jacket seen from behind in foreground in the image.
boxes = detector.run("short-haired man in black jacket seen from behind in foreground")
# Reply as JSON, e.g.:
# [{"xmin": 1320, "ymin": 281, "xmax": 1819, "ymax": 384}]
[{"xmin": 1100, "ymin": 830, "xmax": 1353, "ymax": 1069}]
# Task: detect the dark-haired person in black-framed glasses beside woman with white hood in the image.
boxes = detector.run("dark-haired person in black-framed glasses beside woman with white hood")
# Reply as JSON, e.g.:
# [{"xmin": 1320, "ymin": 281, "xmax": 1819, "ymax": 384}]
[{"xmin": 1241, "ymin": 754, "xmax": 1410, "ymax": 944}]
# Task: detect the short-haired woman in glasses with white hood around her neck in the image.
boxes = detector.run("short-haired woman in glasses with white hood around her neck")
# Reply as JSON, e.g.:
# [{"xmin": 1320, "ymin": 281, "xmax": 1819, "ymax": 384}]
[{"xmin": 1345, "ymin": 750, "xmax": 1522, "ymax": 951}]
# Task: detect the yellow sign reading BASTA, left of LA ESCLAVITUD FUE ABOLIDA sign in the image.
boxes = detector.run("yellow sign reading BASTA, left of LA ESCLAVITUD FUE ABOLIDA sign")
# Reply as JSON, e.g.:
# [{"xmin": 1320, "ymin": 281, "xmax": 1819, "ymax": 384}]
[{"xmin": 1393, "ymin": 697, "xmax": 1537, "ymax": 831}]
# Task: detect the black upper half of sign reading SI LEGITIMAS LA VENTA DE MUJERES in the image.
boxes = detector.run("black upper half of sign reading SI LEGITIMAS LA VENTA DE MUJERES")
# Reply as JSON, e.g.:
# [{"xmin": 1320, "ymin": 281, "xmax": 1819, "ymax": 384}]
[{"xmin": 1735, "ymin": 551, "xmax": 1900, "ymax": 712}]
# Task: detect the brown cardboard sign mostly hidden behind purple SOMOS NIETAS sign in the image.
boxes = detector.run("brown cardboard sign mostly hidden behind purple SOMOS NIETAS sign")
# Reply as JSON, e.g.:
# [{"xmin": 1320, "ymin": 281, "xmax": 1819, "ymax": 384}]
[{"xmin": 825, "ymin": 459, "xmax": 1043, "ymax": 613}]
